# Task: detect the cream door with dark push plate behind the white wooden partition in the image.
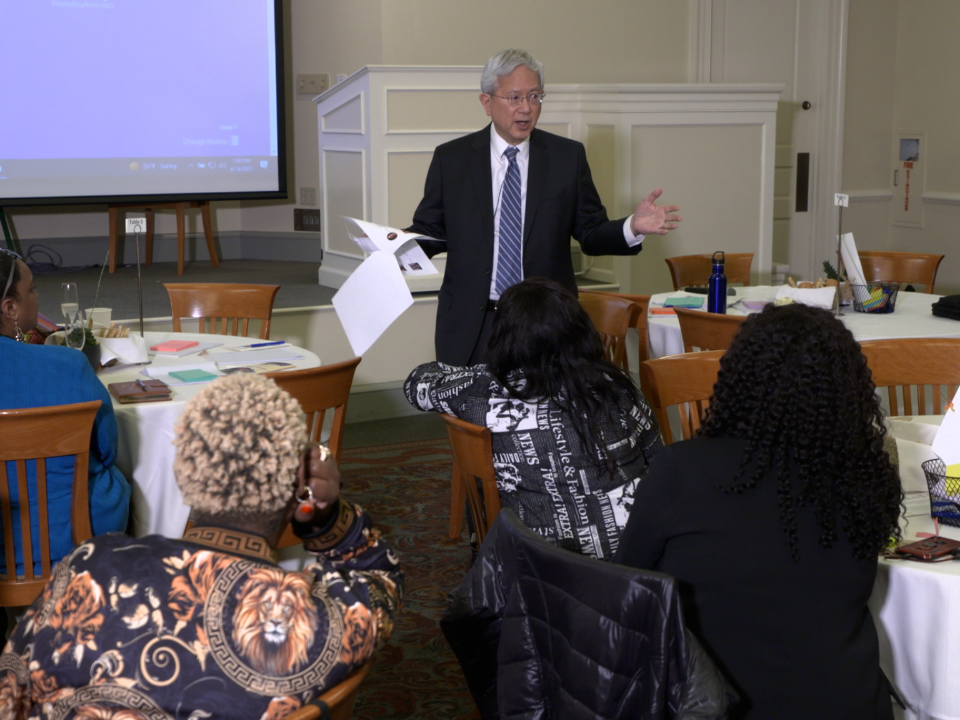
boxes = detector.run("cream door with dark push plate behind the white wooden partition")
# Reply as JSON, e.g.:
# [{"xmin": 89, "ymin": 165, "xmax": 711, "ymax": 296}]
[{"xmin": 698, "ymin": 0, "xmax": 847, "ymax": 278}]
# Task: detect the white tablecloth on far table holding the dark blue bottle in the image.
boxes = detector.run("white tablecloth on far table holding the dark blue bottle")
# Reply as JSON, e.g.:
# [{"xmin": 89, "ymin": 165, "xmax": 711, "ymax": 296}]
[{"xmin": 648, "ymin": 286, "xmax": 960, "ymax": 358}]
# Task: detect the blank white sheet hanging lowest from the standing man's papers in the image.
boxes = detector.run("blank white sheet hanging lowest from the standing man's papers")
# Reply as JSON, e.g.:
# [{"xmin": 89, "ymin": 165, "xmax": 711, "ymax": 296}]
[{"xmin": 333, "ymin": 252, "xmax": 413, "ymax": 356}]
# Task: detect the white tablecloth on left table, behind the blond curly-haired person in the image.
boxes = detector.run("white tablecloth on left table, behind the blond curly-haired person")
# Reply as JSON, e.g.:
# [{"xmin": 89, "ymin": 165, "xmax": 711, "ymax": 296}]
[{"xmin": 98, "ymin": 332, "xmax": 320, "ymax": 538}]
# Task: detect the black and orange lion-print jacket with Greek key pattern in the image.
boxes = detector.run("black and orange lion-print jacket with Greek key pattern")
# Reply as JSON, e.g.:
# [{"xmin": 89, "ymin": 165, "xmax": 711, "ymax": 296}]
[{"xmin": 0, "ymin": 509, "xmax": 402, "ymax": 720}]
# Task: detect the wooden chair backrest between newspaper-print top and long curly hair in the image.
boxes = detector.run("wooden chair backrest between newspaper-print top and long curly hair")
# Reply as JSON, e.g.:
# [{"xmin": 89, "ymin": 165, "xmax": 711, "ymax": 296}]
[{"xmin": 640, "ymin": 350, "xmax": 726, "ymax": 445}]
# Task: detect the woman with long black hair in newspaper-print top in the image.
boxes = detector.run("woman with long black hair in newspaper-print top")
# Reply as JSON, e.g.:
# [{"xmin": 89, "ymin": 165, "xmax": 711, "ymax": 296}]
[{"xmin": 404, "ymin": 278, "xmax": 663, "ymax": 560}]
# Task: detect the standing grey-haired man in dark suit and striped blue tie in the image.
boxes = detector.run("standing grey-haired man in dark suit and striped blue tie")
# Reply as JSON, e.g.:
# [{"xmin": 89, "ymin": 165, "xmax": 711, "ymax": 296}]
[{"xmin": 409, "ymin": 50, "xmax": 680, "ymax": 365}]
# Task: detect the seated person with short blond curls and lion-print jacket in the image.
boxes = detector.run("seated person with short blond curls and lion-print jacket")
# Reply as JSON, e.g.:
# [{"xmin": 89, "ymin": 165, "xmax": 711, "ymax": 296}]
[{"xmin": 0, "ymin": 375, "xmax": 403, "ymax": 720}]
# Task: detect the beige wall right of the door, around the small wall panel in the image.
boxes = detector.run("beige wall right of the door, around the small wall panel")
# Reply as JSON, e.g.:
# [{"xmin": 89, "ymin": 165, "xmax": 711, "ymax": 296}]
[{"xmin": 843, "ymin": 0, "xmax": 960, "ymax": 293}]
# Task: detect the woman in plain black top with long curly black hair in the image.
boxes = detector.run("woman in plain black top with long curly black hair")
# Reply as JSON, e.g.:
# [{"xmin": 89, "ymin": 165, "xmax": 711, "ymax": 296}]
[{"xmin": 617, "ymin": 305, "xmax": 903, "ymax": 720}]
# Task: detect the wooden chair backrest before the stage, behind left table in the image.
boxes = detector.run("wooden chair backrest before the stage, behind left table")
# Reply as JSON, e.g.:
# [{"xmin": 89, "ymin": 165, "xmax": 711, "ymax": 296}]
[{"xmin": 163, "ymin": 283, "xmax": 280, "ymax": 340}]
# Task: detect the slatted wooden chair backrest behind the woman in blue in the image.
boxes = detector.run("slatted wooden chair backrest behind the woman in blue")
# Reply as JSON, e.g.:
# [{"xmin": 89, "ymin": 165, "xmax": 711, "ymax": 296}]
[{"xmin": 0, "ymin": 400, "xmax": 101, "ymax": 607}]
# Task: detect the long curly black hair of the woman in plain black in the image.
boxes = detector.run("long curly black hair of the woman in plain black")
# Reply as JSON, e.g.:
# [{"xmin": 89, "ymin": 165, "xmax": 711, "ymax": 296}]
[{"xmin": 700, "ymin": 304, "xmax": 903, "ymax": 560}]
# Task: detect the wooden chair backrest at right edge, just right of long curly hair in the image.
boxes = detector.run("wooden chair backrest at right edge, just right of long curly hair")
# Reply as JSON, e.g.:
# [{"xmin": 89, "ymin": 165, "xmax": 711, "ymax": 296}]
[{"xmin": 860, "ymin": 338, "xmax": 960, "ymax": 416}]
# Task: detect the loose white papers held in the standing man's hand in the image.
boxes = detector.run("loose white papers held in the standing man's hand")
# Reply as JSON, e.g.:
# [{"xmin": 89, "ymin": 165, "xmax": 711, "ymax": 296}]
[{"xmin": 333, "ymin": 218, "xmax": 437, "ymax": 355}]
